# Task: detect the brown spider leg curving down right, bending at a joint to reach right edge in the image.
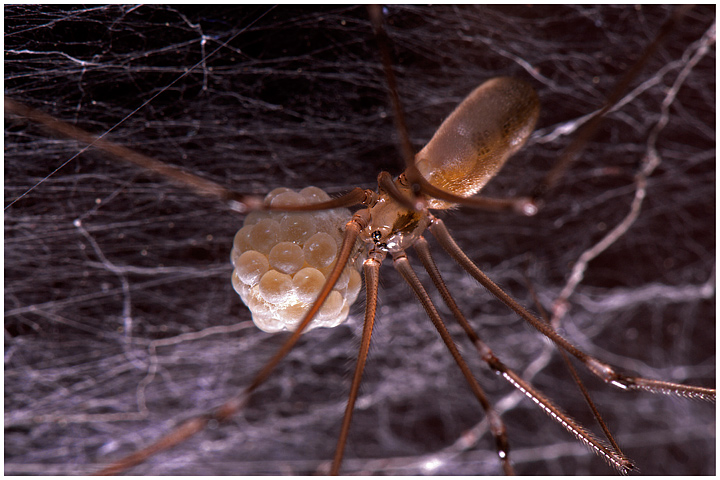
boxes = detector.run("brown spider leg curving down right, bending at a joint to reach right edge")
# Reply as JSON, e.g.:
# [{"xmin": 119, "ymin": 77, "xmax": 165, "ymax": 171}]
[{"xmin": 430, "ymin": 218, "xmax": 715, "ymax": 402}]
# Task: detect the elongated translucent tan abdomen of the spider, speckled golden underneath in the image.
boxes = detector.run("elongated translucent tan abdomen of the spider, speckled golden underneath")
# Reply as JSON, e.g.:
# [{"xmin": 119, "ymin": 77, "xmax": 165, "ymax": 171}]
[{"xmin": 415, "ymin": 77, "xmax": 540, "ymax": 208}]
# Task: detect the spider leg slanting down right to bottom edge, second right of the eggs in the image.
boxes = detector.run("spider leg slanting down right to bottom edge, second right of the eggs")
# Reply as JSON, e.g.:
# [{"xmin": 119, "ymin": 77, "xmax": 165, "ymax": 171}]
[{"xmin": 393, "ymin": 253, "xmax": 514, "ymax": 475}]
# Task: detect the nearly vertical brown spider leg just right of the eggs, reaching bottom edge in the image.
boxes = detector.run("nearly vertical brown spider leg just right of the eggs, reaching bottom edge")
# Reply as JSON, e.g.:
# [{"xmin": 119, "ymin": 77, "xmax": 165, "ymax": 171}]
[{"xmin": 330, "ymin": 250, "xmax": 385, "ymax": 475}]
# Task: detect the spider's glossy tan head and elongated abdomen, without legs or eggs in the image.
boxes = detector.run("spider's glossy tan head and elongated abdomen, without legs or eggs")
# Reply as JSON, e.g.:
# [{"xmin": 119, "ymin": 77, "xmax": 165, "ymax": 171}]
[{"xmin": 361, "ymin": 78, "xmax": 540, "ymax": 253}]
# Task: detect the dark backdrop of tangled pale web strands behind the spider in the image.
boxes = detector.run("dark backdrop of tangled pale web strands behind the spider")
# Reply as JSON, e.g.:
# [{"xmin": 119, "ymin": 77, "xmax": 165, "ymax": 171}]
[{"xmin": 5, "ymin": 7, "xmax": 715, "ymax": 474}]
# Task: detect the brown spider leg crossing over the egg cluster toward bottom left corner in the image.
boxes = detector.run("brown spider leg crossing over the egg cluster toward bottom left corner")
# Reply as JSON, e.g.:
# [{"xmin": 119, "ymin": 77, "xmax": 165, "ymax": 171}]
[{"xmin": 97, "ymin": 211, "xmax": 367, "ymax": 475}]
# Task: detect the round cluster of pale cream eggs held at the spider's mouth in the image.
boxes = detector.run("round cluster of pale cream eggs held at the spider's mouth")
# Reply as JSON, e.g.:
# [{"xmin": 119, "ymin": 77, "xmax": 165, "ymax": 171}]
[{"xmin": 231, "ymin": 187, "xmax": 361, "ymax": 332}]
